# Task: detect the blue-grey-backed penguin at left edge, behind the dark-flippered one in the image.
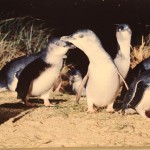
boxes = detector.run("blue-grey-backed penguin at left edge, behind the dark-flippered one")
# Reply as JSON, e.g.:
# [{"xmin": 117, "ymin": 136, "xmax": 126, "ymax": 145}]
[{"xmin": 0, "ymin": 49, "xmax": 46, "ymax": 92}]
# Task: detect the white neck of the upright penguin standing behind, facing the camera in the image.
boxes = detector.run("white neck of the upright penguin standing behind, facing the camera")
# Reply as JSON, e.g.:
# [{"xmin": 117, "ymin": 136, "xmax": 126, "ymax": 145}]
[{"xmin": 118, "ymin": 41, "xmax": 130, "ymax": 59}]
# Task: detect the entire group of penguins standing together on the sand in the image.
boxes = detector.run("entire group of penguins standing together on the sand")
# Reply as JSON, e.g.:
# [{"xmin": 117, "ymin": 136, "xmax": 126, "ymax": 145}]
[{"xmin": 0, "ymin": 24, "xmax": 150, "ymax": 118}]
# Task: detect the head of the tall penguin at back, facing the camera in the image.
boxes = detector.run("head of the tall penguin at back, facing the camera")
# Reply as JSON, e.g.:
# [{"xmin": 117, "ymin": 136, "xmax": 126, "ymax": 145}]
[{"xmin": 116, "ymin": 24, "xmax": 132, "ymax": 42}]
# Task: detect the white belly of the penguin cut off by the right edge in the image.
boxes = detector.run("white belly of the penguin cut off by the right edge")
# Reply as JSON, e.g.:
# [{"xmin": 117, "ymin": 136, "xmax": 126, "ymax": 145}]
[{"xmin": 135, "ymin": 87, "xmax": 150, "ymax": 114}]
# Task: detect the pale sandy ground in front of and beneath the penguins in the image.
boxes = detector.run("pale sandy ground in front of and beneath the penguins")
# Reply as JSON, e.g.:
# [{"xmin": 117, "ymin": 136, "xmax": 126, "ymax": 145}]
[{"xmin": 0, "ymin": 92, "xmax": 150, "ymax": 148}]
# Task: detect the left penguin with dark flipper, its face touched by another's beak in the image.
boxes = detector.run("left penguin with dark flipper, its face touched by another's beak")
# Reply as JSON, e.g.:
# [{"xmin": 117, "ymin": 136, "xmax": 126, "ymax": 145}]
[{"xmin": 16, "ymin": 38, "xmax": 74, "ymax": 106}]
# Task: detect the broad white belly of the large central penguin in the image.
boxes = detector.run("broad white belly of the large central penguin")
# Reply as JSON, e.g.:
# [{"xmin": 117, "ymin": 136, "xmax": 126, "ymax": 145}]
[{"xmin": 86, "ymin": 63, "xmax": 119, "ymax": 107}]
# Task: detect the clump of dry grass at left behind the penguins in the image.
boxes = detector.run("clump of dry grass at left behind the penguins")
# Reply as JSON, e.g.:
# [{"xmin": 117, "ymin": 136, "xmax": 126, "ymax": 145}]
[{"xmin": 0, "ymin": 17, "xmax": 53, "ymax": 68}]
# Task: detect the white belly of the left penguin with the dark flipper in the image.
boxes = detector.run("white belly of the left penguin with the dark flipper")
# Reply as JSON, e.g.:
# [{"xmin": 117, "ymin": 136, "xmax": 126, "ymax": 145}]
[{"xmin": 30, "ymin": 68, "xmax": 60, "ymax": 96}]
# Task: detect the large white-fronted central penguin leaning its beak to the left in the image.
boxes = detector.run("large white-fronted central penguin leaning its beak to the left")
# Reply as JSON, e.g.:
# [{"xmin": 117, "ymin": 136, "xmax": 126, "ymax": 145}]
[{"xmin": 61, "ymin": 29, "xmax": 127, "ymax": 112}]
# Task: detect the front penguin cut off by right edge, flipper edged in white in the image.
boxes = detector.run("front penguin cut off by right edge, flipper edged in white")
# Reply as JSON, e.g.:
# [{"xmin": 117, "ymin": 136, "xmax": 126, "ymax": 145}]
[{"xmin": 122, "ymin": 69, "xmax": 150, "ymax": 118}]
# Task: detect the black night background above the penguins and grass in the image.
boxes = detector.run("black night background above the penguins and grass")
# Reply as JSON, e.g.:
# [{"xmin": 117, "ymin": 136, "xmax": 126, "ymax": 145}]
[{"xmin": 0, "ymin": 0, "xmax": 150, "ymax": 74}]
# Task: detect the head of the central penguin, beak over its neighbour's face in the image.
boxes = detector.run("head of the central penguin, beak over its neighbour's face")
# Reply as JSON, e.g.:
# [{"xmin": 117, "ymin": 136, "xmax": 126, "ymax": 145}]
[{"xmin": 61, "ymin": 29, "xmax": 100, "ymax": 51}]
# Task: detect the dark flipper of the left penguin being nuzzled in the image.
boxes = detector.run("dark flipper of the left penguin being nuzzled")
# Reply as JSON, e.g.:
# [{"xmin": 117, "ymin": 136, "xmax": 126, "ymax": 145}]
[{"xmin": 16, "ymin": 58, "xmax": 50, "ymax": 99}]
